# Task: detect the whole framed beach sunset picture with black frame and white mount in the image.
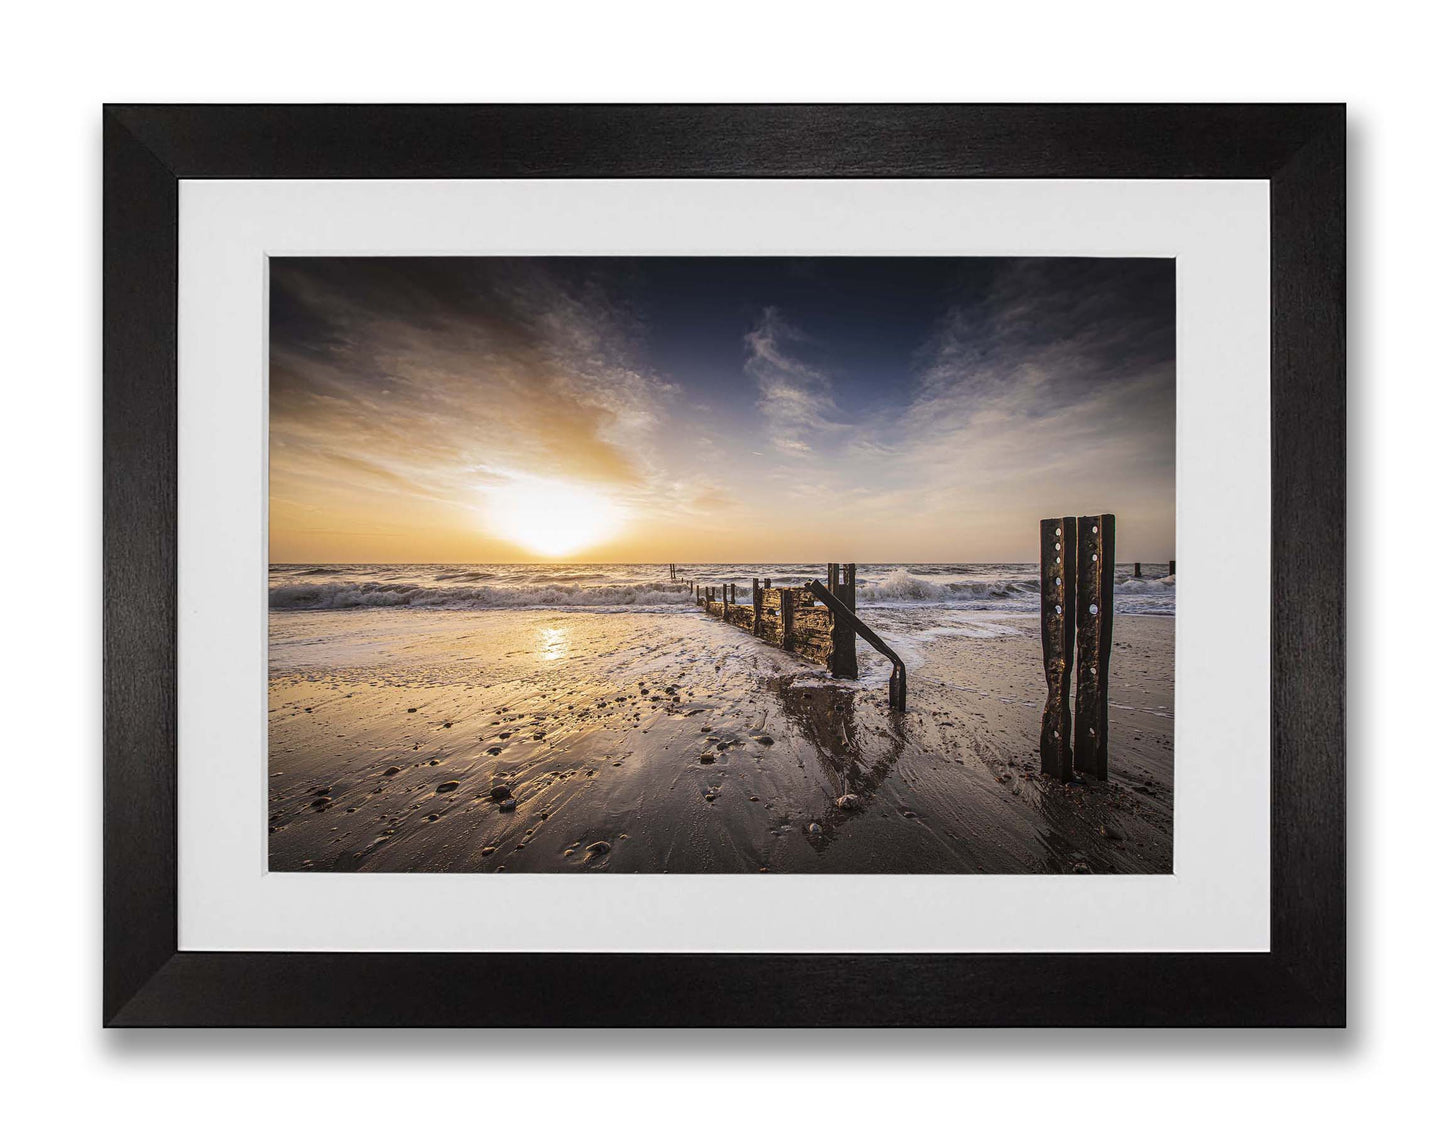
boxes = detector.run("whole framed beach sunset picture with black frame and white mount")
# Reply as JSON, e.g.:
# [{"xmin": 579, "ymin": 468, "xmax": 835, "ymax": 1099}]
[{"xmin": 104, "ymin": 105, "xmax": 1345, "ymax": 1026}]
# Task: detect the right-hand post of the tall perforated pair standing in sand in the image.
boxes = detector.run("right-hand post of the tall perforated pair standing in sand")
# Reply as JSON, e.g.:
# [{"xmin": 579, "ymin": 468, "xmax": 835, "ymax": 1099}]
[{"xmin": 1074, "ymin": 513, "xmax": 1114, "ymax": 779}]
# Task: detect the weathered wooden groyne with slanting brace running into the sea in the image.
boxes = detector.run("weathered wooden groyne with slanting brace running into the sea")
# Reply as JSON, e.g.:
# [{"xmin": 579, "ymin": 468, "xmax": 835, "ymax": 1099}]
[{"xmin": 688, "ymin": 564, "xmax": 907, "ymax": 712}]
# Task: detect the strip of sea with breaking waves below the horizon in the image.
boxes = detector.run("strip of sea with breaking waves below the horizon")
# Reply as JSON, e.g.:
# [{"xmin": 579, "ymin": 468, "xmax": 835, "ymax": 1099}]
[{"xmin": 270, "ymin": 564, "xmax": 1175, "ymax": 616}]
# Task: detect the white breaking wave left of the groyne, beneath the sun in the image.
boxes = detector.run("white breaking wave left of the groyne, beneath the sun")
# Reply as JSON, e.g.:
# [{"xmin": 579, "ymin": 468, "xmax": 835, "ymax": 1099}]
[{"xmin": 270, "ymin": 582, "xmax": 692, "ymax": 610}]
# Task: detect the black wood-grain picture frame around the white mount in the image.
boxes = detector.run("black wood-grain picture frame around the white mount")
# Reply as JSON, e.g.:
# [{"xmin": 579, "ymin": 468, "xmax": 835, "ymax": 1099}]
[{"xmin": 103, "ymin": 104, "xmax": 1345, "ymax": 1026}]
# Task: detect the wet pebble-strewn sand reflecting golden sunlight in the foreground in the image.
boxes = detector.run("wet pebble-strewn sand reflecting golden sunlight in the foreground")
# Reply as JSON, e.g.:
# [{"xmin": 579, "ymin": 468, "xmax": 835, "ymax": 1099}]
[{"xmin": 269, "ymin": 608, "xmax": 1175, "ymax": 874}]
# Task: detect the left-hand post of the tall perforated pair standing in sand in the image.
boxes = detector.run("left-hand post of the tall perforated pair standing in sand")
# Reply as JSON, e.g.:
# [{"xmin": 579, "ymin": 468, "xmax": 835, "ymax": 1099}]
[{"xmin": 1039, "ymin": 517, "xmax": 1078, "ymax": 782}]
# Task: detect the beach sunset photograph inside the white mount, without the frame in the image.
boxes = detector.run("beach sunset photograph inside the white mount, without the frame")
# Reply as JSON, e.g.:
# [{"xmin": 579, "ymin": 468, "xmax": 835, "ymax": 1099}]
[{"xmin": 266, "ymin": 257, "xmax": 1188, "ymax": 878}]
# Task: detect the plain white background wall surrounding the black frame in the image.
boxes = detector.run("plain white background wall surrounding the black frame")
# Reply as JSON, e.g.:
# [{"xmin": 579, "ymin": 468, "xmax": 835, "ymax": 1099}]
[{"xmin": 0, "ymin": 0, "xmax": 1421, "ymax": 1124}]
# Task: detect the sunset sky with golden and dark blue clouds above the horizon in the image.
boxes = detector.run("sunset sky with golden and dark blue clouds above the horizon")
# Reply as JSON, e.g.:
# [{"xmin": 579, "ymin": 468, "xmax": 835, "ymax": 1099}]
[{"xmin": 270, "ymin": 257, "xmax": 1175, "ymax": 564}]
